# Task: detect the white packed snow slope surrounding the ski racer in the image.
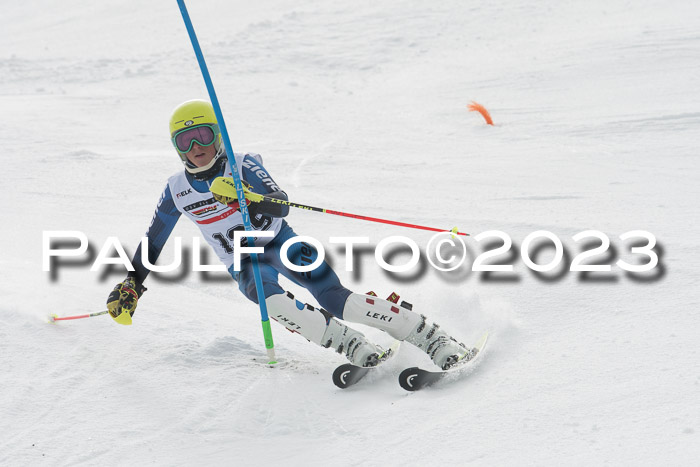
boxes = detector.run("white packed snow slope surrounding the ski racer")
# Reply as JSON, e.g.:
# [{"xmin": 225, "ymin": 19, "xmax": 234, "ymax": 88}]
[{"xmin": 0, "ymin": 0, "xmax": 700, "ymax": 465}]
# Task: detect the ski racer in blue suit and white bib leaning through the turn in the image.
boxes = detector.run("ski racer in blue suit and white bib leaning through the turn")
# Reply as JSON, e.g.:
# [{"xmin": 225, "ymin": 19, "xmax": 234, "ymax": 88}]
[{"xmin": 107, "ymin": 100, "xmax": 475, "ymax": 369}]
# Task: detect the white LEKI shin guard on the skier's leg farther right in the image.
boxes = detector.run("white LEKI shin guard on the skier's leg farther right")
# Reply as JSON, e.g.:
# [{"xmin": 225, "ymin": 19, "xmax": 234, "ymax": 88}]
[{"xmin": 343, "ymin": 293, "xmax": 421, "ymax": 340}]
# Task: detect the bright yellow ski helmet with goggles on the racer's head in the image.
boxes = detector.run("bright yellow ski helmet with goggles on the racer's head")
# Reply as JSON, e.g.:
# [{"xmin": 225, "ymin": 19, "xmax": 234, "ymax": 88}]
[{"xmin": 170, "ymin": 99, "xmax": 226, "ymax": 180}]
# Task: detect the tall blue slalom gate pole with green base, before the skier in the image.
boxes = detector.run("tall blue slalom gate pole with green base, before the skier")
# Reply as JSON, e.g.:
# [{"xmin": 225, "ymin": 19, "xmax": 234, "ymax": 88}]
[{"xmin": 177, "ymin": 0, "xmax": 277, "ymax": 364}]
